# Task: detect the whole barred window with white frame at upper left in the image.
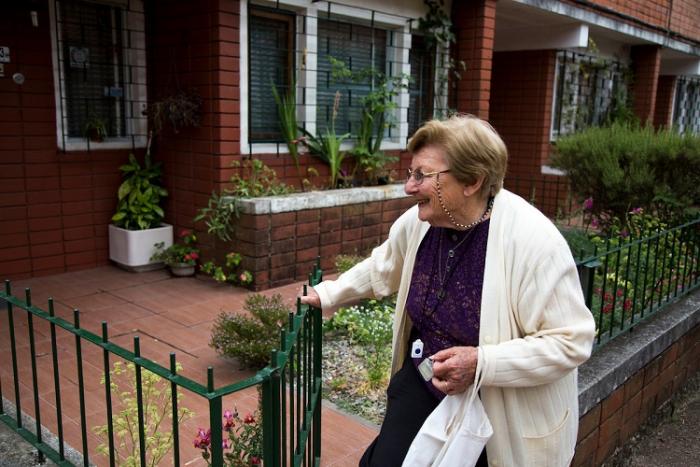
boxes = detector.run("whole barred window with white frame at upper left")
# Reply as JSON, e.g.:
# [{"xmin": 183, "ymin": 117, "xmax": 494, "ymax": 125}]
[{"xmin": 50, "ymin": 0, "xmax": 146, "ymax": 149}]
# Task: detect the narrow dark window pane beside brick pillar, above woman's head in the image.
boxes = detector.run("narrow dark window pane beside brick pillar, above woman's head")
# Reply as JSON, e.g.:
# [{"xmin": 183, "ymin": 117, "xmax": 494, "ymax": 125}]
[{"xmin": 408, "ymin": 35, "xmax": 435, "ymax": 136}]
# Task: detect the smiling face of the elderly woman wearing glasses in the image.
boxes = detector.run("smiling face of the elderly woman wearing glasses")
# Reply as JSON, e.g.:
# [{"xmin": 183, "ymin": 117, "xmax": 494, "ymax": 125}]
[{"xmin": 404, "ymin": 145, "xmax": 465, "ymax": 227}]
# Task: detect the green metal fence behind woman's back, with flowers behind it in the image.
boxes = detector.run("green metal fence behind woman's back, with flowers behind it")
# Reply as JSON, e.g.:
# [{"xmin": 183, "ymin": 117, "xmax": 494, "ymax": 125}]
[{"xmin": 576, "ymin": 219, "xmax": 700, "ymax": 346}]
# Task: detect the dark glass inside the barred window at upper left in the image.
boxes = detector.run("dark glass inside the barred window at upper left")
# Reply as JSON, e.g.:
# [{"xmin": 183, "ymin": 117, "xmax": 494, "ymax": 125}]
[{"xmin": 59, "ymin": 1, "xmax": 126, "ymax": 137}]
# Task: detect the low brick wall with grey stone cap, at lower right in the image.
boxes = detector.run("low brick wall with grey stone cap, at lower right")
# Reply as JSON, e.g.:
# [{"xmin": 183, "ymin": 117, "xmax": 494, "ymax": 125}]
[{"xmin": 571, "ymin": 290, "xmax": 700, "ymax": 467}]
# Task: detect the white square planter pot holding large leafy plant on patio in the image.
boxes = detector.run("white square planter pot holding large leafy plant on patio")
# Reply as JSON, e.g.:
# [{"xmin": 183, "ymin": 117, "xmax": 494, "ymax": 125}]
[{"xmin": 109, "ymin": 224, "xmax": 173, "ymax": 271}]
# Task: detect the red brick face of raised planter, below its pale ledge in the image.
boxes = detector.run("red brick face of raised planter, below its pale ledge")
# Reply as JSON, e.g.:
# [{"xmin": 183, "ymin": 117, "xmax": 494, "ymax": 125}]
[{"xmin": 226, "ymin": 198, "xmax": 414, "ymax": 290}]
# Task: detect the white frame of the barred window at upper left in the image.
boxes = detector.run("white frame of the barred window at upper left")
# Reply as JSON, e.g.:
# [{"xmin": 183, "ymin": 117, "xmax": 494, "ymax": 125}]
[{"xmin": 49, "ymin": 0, "xmax": 148, "ymax": 151}]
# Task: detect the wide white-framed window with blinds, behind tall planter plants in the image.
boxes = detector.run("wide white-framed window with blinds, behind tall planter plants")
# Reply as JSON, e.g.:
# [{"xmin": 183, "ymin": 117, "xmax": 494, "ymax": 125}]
[{"xmin": 240, "ymin": 0, "xmax": 422, "ymax": 154}]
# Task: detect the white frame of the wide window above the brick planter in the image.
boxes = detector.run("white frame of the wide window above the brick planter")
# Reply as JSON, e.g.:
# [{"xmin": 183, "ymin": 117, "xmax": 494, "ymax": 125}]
[{"xmin": 240, "ymin": 0, "xmax": 418, "ymax": 154}]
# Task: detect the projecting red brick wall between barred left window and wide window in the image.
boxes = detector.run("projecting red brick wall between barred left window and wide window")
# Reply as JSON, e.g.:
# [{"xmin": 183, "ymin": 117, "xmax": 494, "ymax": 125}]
[{"xmin": 146, "ymin": 0, "xmax": 240, "ymax": 242}]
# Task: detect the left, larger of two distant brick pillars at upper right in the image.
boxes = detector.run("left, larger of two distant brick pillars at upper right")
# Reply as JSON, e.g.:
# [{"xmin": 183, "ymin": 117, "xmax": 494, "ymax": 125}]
[{"xmin": 632, "ymin": 45, "xmax": 661, "ymax": 123}]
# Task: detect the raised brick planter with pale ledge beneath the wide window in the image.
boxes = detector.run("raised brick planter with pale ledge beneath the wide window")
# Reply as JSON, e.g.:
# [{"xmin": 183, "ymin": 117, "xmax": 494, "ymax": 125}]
[{"xmin": 227, "ymin": 184, "xmax": 413, "ymax": 290}]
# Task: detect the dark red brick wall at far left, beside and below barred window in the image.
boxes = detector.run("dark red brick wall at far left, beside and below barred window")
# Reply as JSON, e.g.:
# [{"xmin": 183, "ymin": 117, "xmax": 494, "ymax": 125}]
[{"xmin": 0, "ymin": 2, "xmax": 134, "ymax": 279}]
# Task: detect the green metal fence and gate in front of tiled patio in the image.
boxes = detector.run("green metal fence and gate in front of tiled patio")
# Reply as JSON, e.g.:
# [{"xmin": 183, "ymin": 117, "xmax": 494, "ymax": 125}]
[{"xmin": 0, "ymin": 265, "xmax": 322, "ymax": 466}]
